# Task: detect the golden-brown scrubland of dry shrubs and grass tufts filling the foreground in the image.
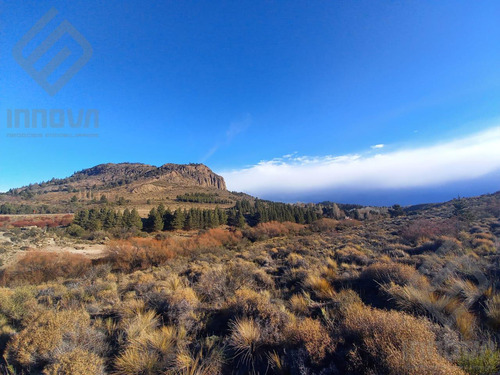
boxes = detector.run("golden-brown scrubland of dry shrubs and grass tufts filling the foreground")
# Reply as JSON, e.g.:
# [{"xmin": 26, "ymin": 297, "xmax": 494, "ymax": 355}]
[{"xmin": 0, "ymin": 195, "xmax": 500, "ymax": 375}]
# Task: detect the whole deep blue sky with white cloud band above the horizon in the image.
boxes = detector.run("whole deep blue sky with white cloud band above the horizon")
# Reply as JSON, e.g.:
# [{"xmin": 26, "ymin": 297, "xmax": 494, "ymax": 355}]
[{"xmin": 0, "ymin": 0, "xmax": 500, "ymax": 204}]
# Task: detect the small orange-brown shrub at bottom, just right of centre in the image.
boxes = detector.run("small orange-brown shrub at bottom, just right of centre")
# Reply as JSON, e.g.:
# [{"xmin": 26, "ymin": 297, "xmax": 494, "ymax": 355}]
[{"xmin": 288, "ymin": 318, "xmax": 333, "ymax": 364}]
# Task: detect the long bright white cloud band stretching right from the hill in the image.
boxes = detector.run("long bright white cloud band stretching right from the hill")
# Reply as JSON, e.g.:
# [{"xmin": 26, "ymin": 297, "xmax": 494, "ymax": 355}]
[{"xmin": 221, "ymin": 127, "xmax": 500, "ymax": 196}]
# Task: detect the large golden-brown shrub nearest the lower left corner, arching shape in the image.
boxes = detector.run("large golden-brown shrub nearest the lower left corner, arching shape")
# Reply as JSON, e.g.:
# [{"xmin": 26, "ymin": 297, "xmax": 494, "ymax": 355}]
[{"xmin": 7, "ymin": 310, "xmax": 108, "ymax": 368}]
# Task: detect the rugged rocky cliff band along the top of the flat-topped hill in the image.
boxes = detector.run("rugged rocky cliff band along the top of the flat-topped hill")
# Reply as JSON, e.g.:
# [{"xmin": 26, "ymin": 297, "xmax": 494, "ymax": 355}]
[{"xmin": 69, "ymin": 163, "xmax": 226, "ymax": 190}]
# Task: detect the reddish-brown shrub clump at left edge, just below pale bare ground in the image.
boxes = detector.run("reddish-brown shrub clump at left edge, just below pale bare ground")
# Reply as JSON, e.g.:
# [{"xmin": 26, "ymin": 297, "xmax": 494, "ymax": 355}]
[{"xmin": 4, "ymin": 251, "xmax": 91, "ymax": 285}]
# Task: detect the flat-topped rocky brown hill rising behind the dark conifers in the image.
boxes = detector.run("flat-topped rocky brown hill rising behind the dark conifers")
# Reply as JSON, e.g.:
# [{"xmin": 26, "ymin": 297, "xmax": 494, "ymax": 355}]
[{"xmin": 0, "ymin": 163, "xmax": 252, "ymax": 215}]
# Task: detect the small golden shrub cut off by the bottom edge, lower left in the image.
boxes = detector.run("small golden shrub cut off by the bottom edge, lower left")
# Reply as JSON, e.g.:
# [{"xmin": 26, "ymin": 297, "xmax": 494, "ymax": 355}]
[{"xmin": 43, "ymin": 348, "xmax": 105, "ymax": 375}]
